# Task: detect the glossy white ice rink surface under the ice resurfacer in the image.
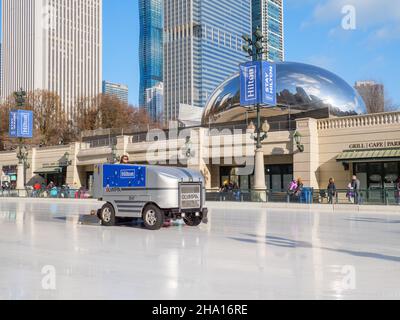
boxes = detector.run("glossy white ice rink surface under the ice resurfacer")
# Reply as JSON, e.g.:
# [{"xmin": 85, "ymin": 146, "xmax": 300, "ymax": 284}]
[{"xmin": 0, "ymin": 199, "xmax": 400, "ymax": 300}]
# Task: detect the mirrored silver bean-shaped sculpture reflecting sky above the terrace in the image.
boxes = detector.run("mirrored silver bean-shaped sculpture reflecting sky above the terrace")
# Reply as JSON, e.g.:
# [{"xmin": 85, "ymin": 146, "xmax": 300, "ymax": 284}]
[{"xmin": 202, "ymin": 62, "xmax": 366, "ymax": 130}]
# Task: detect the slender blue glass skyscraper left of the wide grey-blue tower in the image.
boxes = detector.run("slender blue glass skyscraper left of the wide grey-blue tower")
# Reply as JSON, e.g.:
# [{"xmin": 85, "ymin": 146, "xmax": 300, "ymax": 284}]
[{"xmin": 139, "ymin": 0, "xmax": 163, "ymax": 113}]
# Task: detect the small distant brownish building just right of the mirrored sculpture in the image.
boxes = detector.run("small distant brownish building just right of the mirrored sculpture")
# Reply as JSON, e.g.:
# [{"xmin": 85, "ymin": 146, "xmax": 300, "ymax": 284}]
[{"xmin": 355, "ymin": 81, "xmax": 385, "ymax": 113}]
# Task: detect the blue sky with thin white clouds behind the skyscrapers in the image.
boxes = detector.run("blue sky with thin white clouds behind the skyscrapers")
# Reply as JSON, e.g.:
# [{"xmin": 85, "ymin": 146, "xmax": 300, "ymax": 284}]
[{"xmin": 0, "ymin": 0, "xmax": 400, "ymax": 106}]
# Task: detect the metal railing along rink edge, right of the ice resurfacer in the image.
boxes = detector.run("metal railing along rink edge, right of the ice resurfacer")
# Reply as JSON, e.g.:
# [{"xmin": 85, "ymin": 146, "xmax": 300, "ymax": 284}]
[{"xmin": 206, "ymin": 188, "xmax": 400, "ymax": 206}]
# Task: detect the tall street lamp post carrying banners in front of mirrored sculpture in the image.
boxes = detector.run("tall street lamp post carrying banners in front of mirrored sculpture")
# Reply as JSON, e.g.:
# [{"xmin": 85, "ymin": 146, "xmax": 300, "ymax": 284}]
[{"xmin": 242, "ymin": 27, "xmax": 270, "ymax": 201}]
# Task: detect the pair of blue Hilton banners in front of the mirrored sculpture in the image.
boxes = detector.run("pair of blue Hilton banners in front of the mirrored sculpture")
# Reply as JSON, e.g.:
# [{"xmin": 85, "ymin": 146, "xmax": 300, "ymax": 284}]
[{"xmin": 240, "ymin": 61, "xmax": 277, "ymax": 107}]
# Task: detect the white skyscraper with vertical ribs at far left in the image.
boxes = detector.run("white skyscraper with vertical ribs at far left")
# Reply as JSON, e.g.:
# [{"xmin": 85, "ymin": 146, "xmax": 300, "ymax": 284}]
[{"xmin": 1, "ymin": 0, "xmax": 102, "ymax": 119}]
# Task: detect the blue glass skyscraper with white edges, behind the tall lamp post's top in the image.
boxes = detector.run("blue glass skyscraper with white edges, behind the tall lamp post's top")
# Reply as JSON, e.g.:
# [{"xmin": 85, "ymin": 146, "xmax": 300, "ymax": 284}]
[{"xmin": 252, "ymin": 0, "xmax": 285, "ymax": 61}]
